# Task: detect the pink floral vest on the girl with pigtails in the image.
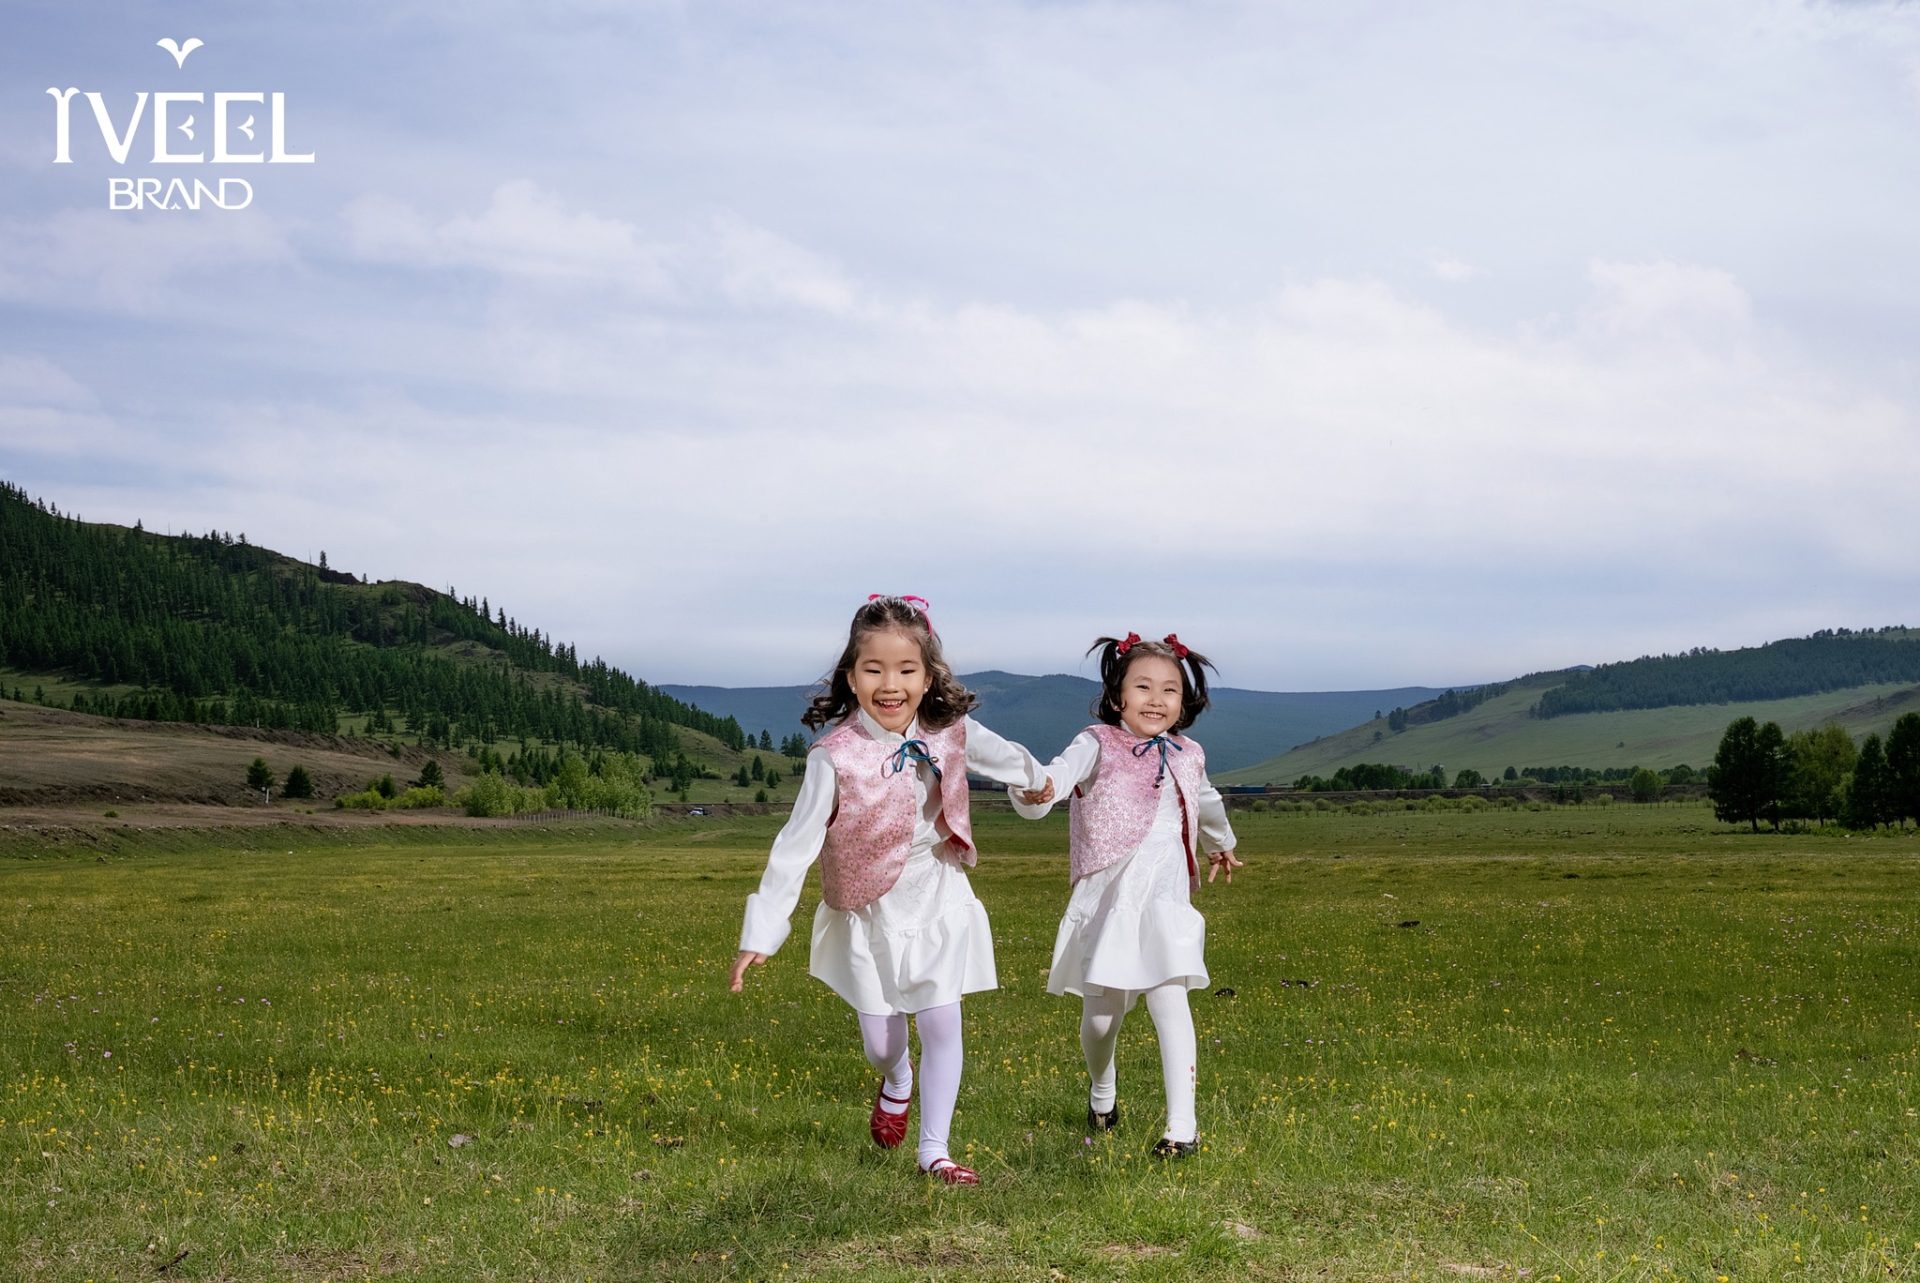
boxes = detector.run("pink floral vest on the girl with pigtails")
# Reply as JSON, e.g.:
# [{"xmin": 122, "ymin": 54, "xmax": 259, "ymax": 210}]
[{"xmin": 1068, "ymin": 724, "xmax": 1206, "ymax": 882}]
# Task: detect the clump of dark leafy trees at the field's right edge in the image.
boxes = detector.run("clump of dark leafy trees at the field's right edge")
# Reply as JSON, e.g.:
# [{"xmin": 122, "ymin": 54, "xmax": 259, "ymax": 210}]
[{"xmin": 1707, "ymin": 713, "xmax": 1920, "ymax": 832}]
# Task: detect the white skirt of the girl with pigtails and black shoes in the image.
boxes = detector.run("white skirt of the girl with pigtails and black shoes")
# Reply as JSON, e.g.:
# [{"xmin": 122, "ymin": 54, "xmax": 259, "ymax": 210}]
[{"xmin": 1046, "ymin": 789, "xmax": 1210, "ymax": 1006}]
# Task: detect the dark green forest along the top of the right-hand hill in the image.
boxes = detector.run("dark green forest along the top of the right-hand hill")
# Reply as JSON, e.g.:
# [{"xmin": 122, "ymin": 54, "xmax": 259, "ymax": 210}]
[{"xmin": 1532, "ymin": 628, "xmax": 1920, "ymax": 716}]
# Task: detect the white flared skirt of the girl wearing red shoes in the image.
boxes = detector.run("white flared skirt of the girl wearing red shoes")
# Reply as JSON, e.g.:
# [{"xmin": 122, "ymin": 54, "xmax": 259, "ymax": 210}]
[{"xmin": 806, "ymin": 847, "xmax": 1000, "ymax": 1016}]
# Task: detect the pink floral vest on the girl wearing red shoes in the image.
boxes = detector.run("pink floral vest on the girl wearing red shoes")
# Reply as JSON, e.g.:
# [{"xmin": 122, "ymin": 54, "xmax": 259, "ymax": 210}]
[{"xmin": 818, "ymin": 718, "xmax": 975, "ymax": 908}]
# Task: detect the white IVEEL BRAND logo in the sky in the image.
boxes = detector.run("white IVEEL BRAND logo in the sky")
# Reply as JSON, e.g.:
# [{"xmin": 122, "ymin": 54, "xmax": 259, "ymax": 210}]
[{"xmin": 46, "ymin": 36, "xmax": 313, "ymax": 209}]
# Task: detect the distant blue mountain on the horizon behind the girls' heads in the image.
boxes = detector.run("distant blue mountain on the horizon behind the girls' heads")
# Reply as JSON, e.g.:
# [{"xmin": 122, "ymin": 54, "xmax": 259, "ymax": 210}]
[{"xmin": 655, "ymin": 670, "xmax": 1444, "ymax": 770}]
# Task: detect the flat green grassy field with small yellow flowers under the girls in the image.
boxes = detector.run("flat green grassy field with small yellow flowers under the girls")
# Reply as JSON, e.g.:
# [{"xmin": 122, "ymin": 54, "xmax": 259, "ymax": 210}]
[{"xmin": 0, "ymin": 805, "xmax": 1920, "ymax": 1281}]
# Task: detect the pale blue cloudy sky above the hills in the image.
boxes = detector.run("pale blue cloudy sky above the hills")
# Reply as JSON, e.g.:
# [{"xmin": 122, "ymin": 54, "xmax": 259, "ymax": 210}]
[{"xmin": 0, "ymin": 0, "xmax": 1920, "ymax": 690}]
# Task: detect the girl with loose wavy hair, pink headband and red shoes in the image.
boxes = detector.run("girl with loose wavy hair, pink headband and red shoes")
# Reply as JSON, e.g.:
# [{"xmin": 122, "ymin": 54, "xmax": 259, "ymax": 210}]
[{"xmin": 732, "ymin": 593, "xmax": 1052, "ymax": 1185}]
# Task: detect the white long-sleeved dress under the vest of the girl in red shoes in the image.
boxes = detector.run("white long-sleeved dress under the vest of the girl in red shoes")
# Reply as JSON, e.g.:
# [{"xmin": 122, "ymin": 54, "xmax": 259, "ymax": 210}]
[{"xmin": 739, "ymin": 711, "xmax": 1046, "ymax": 1016}]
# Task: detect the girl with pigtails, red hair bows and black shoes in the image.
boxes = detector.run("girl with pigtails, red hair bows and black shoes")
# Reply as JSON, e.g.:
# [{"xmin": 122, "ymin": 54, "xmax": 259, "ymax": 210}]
[{"xmin": 1014, "ymin": 632, "xmax": 1240, "ymax": 1158}]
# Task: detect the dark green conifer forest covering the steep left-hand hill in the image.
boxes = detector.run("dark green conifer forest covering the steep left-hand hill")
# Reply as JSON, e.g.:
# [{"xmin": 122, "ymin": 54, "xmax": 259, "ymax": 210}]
[{"xmin": 0, "ymin": 482, "xmax": 745, "ymax": 763}]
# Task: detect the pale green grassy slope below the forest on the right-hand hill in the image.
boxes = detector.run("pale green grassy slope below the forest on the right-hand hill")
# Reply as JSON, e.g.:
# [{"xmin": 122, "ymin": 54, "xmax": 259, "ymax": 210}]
[{"xmin": 1228, "ymin": 682, "xmax": 1920, "ymax": 784}]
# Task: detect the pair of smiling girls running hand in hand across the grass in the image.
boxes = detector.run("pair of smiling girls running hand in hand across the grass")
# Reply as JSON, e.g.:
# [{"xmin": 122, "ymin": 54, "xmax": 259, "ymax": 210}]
[{"xmin": 732, "ymin": 597, "xmax": 1240, "ymax": 1185}]
